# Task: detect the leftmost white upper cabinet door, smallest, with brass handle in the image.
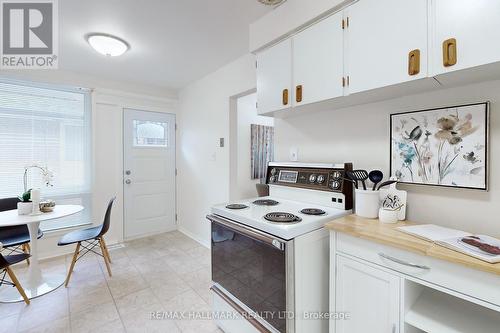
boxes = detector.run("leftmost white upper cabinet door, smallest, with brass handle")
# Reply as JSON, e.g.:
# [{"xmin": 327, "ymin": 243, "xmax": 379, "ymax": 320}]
[{"xmin": 257, "ymin": 39, "xmax": 292, "ymax": 114}]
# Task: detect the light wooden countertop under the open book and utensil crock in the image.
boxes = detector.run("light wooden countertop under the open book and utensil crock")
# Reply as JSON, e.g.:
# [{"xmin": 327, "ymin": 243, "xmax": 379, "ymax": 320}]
[{"xmin": 325, "ymin": 215, "xmax": 500, "ymax": 275}]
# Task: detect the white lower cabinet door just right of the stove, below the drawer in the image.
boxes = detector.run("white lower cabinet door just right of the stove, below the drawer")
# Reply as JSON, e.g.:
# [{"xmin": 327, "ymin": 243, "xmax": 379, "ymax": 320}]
[{"xmin": 335, "ymin": 256, "xmax": 400, "ymax": 333}]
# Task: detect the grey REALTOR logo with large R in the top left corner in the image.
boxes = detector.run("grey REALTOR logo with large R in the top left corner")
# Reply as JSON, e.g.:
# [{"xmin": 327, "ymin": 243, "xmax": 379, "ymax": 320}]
[{"xmin": 0, "ymin": 0, "xmax": 58, "ymax": 69}]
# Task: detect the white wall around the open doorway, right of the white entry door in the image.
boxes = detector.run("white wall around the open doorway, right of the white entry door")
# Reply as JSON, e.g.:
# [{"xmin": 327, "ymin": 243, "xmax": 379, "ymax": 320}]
[{"xmin": 177, "ymin": 55, "xmax": 256, "ymax": 245}]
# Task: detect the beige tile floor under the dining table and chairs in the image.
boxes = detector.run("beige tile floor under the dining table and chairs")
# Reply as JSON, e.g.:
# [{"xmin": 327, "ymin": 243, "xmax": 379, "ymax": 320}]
[{"xmin": 0, "ymin": 231, "xmax": 222, "ymax": 333}]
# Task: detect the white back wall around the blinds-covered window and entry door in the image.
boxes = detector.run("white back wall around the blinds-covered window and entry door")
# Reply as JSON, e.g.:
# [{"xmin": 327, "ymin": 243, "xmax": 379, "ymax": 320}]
[{"xmin": 1, "ymin": 71, "xmax": 177, "ymax": 258}]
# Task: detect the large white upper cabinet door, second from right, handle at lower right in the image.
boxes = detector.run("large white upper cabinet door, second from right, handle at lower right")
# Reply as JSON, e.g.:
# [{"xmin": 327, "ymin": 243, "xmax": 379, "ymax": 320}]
[{"xmin": 346, "ymin": 0, "xmax": 428, "ymax": 93}]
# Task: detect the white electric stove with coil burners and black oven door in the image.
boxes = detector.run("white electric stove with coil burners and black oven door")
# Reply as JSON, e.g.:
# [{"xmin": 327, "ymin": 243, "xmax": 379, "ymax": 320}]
[{"xmin": 207, "ymin": 162, "xmax": 352, "ymax": 333}]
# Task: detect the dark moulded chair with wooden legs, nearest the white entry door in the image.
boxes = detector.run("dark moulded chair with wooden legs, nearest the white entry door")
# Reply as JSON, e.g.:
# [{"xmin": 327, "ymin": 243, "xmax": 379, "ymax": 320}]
[{"xmin": 57, "ymin": 197, "xmax": 116, "ymax": 287}]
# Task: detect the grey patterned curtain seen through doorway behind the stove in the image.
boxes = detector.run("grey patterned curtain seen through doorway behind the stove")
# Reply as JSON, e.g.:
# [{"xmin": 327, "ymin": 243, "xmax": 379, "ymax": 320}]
[{"xmin": 250, "ymin": 124, "xmax": 274, "ymax": 179}]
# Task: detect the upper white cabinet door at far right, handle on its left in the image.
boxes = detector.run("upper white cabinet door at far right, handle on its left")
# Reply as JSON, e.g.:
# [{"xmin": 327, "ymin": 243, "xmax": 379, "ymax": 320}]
[{"xmin": 432, "ymin": 0, "xmax": 500, "ymax": 74}]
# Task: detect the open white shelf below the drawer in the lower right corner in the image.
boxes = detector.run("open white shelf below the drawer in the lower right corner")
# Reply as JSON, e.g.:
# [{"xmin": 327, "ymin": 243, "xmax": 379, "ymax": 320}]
[{"xmin": 405, "ymin": 282, "xmax": 500, "ymax": 333}]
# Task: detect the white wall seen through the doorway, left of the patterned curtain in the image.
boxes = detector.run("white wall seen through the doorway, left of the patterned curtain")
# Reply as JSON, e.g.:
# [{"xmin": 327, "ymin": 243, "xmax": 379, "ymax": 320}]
[{"xmin": 231, "ymin": 93, "xmax": 274, "ymax": 200}]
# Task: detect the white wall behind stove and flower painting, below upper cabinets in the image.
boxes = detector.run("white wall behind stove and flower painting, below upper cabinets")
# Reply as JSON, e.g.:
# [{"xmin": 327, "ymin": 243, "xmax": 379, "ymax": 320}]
[{"xmin": 275, "ymin": 81, "xmax": 500, "ymax": 236}]
